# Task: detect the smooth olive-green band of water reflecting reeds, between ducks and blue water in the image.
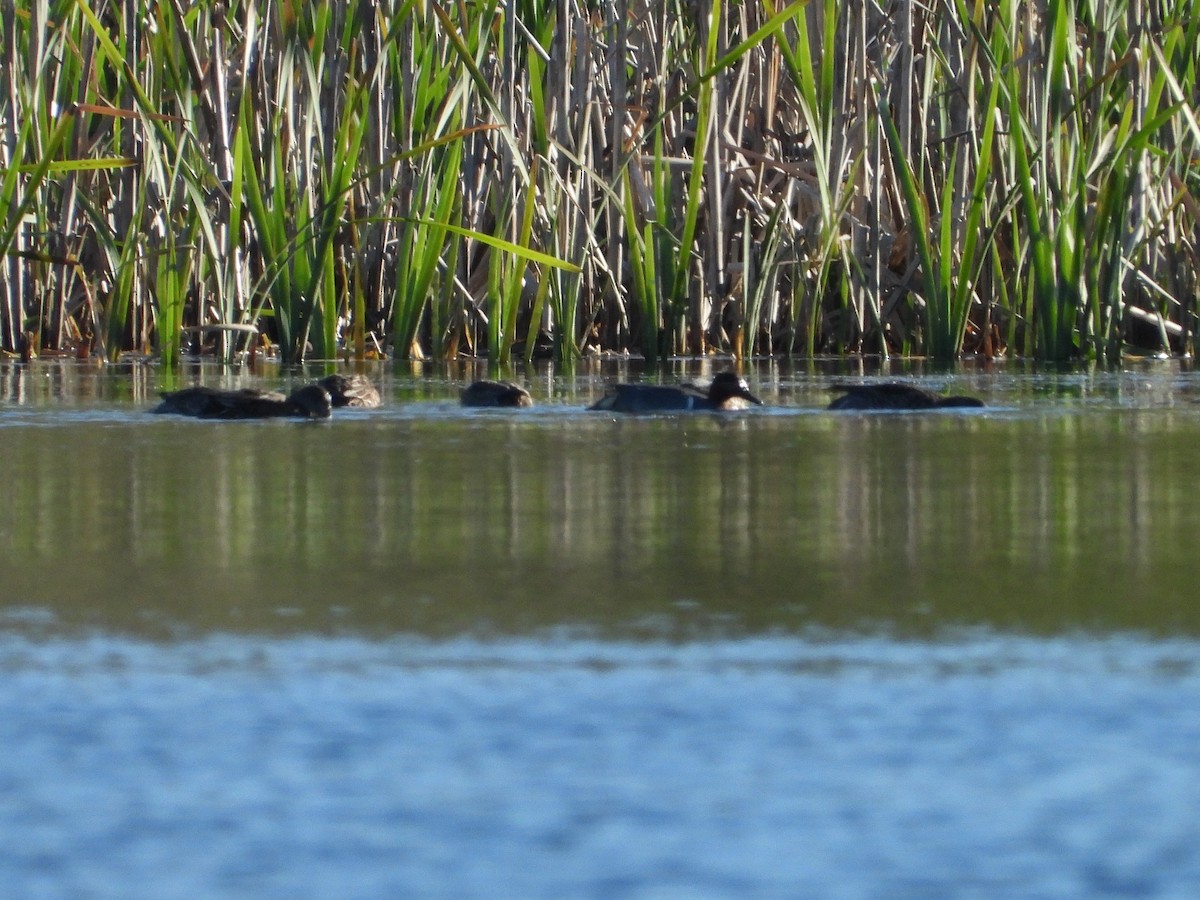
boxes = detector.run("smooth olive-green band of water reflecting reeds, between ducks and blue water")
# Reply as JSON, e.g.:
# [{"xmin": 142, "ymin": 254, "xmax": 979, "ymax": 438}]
[{"xmin": 0, "ymin": 404, "xmax": 1200, "ymax": 636}]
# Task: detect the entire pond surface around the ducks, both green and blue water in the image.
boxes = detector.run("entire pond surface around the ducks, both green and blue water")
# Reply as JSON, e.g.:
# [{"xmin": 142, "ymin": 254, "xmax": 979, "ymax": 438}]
[{"xmin": 0, "ymin": 362, "xmax": 1200, "ymax": 898}]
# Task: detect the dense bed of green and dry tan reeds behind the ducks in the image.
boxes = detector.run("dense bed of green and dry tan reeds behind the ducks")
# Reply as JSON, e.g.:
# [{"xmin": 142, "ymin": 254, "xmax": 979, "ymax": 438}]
[{"xmin": 0, "ymin": 0, "xmax": 1200, "ymax": 364}]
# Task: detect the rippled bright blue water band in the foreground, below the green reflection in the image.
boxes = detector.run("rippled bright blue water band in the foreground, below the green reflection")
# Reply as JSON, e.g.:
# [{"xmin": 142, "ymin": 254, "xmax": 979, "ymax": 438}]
[{"xmin": 0, "ymin": 632, "xmax": 1200, "ymax": 898}]
